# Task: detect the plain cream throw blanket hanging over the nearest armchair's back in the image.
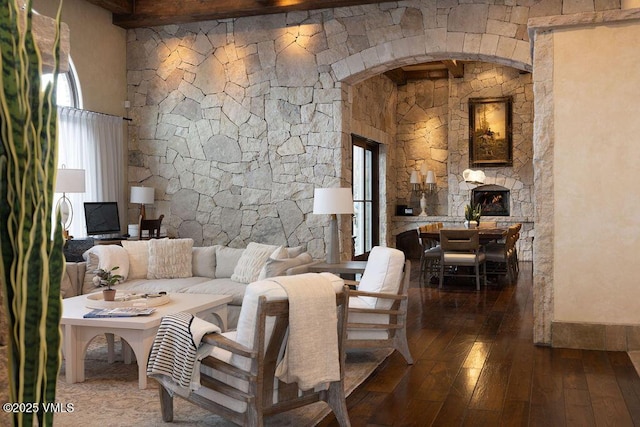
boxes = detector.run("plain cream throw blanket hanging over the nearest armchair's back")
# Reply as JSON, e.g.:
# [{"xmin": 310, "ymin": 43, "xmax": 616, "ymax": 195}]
[{"xmin": 269, "ymin": 273, "xmax": 340, "ymax": 390}]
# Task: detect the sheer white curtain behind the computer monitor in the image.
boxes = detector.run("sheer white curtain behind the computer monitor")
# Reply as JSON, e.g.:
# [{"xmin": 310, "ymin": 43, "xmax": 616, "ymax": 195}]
[{"xmin": 54, "ymin": 107, "xmax": 126, "ymax": 237}]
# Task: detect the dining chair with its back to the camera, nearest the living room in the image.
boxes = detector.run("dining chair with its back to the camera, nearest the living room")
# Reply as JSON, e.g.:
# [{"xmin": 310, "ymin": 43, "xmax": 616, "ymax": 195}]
[{"xmin": 439, "ymin": 228, "xmax": 487, "ymax": 290}]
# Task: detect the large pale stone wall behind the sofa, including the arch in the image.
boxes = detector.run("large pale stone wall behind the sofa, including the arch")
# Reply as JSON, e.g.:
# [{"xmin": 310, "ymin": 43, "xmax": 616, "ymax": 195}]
[{"xmin": 127, "ymin": 0, "xmax": 620, "ymax": 342}]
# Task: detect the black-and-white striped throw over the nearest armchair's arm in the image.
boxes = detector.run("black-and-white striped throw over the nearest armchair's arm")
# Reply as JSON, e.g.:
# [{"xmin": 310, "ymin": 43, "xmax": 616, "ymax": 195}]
[{"xmin": 147, "ymin": 312, "xmax": 220, "ymax": 395}]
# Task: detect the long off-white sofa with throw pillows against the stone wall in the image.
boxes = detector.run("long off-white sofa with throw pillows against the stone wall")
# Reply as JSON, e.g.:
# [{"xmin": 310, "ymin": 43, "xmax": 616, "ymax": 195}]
[{"xmin": 61, "ymin": 239, "xmax": 313, "ymax": 329}]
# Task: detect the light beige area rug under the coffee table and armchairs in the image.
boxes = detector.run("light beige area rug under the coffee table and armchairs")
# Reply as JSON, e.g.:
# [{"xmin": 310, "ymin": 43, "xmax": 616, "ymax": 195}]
[{"xmin": 54, "ymin": 337, "xmax": 391, "ymax": 427}]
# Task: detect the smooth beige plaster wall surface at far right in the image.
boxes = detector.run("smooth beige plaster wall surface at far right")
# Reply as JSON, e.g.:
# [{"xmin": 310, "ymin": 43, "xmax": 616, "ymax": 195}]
[{"xmin": 553, "ymin": 23, "xmax": 640, "ymax": 324}]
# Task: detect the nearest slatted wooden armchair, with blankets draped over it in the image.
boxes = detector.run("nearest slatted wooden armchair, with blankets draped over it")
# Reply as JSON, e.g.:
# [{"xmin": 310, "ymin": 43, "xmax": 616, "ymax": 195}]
[{"xmin": 154, "ymin": 273, "xmax": 350, "ymax": 427}]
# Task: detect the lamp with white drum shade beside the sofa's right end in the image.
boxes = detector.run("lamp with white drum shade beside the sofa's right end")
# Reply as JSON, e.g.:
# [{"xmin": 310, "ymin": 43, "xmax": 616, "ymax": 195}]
[{"xmin": 313, "ymin": 188, "xmax": 353, "ymax": 264}]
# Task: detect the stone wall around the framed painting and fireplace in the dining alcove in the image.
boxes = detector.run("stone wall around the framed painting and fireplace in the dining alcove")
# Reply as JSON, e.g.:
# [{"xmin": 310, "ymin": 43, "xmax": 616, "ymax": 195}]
[{"xmin": 396, "ymin": 62, "xmax": 533, "ymax": 221}]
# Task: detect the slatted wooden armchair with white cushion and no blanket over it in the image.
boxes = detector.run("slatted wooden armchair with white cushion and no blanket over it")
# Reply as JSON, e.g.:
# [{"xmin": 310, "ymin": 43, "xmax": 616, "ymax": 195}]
[{"xmin": 346, "ymin": 246, "xmax": 413, "ymax": 365}]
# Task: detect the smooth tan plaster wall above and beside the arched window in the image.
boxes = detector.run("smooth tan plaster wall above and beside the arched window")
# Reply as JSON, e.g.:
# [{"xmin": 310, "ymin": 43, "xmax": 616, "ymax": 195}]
[{"xmin": 33, "ymin": 0, "xmax": 127, "ymax": 116}]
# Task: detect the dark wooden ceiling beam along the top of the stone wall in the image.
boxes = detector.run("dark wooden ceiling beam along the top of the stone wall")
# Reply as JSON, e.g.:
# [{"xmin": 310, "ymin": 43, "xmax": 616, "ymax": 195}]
[{"xmin": 88, "ymin": 0, "xmax": 396, "ymax": 28}]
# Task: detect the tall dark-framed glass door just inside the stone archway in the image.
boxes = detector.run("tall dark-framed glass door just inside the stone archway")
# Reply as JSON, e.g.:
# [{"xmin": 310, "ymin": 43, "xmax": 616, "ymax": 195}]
[{"xmin": 352, "ymin": 135, "xmax": 380, "ymax": 260}]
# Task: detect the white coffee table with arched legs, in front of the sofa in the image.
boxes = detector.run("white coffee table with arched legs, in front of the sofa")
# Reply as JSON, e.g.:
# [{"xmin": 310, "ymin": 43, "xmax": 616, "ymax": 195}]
[{"xmin": 60, "ymin": 294, "xmax": 232, "ymax": 389}]
